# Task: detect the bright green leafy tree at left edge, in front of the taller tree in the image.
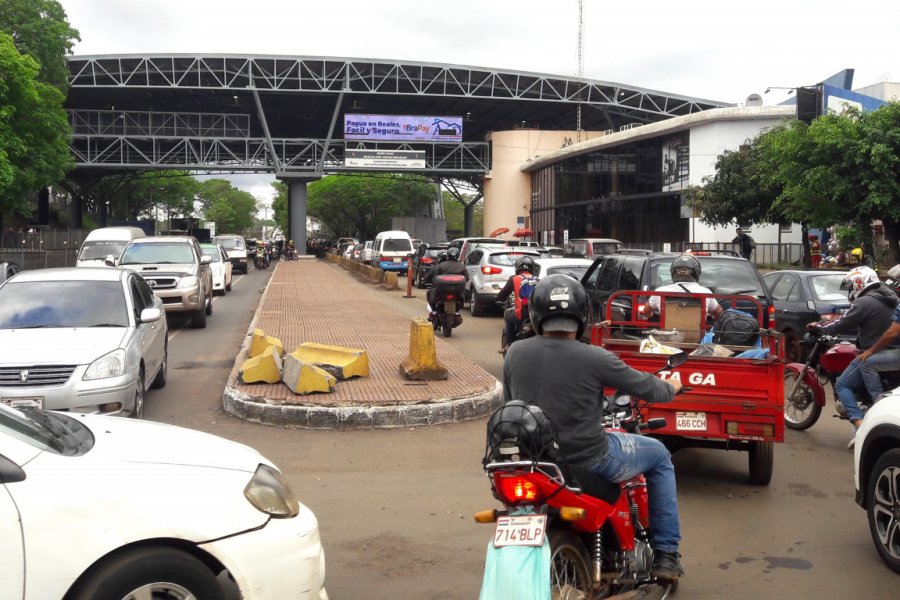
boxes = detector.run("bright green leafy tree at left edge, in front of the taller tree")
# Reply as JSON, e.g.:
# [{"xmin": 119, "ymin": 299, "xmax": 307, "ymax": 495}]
[{"xmin": 0, "ymin": 33, "xmax": 72, "ymax": 215}]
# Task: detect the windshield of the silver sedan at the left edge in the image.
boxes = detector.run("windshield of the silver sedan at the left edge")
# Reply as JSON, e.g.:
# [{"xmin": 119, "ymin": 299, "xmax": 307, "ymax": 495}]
[{"xmin": 0, "ymin": 281, "xmax": 129, "ymax": 329}]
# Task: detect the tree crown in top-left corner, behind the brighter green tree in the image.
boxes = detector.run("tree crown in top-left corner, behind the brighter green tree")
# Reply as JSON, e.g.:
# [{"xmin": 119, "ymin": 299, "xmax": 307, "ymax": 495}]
[{"xmin": 0, "ymin": 0, "xmax": 81, "ymax": 92}]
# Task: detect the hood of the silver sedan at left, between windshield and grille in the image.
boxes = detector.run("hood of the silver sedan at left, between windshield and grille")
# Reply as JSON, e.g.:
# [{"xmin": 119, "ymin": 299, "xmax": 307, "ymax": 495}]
[{"xmin": 0, "ymin": 327, "xmax": 128, "ymax": 365}]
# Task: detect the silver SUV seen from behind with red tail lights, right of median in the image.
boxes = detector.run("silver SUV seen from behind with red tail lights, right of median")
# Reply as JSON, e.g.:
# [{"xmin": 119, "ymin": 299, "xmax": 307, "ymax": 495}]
[{"xmin": 465, "ymin": 245, "xmax": 541, "ymax": 317}]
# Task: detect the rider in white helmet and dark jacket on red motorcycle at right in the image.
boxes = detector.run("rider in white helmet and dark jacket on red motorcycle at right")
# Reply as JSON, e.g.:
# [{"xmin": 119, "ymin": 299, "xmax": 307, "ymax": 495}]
[{"xmin": 806, "ymin": 267, "xmax": 898, "ymax": 449}]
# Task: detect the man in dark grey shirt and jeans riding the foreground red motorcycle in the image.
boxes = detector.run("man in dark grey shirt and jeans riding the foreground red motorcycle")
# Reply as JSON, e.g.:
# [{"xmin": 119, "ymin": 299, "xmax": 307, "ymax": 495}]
[{"xmin": 503, "ymin": 274, "xmax": 684, "ymax": 581}]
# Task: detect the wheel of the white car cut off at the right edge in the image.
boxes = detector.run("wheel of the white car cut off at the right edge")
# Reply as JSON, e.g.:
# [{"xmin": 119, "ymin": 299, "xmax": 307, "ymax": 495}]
[{"xmin": 866, "ymin": 448, "xmax": 900, "ymax": 573}]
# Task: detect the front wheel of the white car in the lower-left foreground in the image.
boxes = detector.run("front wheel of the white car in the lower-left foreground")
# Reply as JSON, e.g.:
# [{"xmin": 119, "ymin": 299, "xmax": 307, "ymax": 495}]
[{"xmin": 71, "ymin": 548, "xmax": 224, "ymax": 600}]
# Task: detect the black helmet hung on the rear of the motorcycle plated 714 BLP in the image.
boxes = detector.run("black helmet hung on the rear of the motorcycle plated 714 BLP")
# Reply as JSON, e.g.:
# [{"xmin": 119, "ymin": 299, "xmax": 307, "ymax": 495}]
[{"xmin": 484, "ymin": 400, "xmax": 559, "ymax": 464}]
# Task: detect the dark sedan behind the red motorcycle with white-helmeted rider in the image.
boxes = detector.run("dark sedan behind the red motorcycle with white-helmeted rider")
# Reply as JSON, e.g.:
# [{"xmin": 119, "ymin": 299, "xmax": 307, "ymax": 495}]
[{"xmin": 763, "ymin": 269, "xmax": 850, "ymax": 362}]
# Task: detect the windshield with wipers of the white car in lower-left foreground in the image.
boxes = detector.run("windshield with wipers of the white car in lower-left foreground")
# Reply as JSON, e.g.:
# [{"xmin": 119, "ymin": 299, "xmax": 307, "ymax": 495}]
[{"xmin": 0, "ymin": 407, "xmax": 94, "ymax": 456}]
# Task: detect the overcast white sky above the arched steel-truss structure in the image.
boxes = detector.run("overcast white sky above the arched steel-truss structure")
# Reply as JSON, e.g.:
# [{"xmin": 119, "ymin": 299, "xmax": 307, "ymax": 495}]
[{"xmin": 59, "ymin": 0, "xmax": 900, "ymax": 202}]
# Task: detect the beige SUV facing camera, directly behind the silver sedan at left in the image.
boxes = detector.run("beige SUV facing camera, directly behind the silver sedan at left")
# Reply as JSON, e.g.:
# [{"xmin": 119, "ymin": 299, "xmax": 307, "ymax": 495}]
[{"xmin": 119, "ymin": 235, "xmax": 214, "ymax": 328}]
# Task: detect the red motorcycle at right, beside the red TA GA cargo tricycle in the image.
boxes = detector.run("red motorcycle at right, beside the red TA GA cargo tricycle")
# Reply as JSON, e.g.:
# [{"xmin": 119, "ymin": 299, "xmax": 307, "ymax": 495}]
[{"xmin": 784, "ymin": 332, "xmax": 900, "ymax": 431}]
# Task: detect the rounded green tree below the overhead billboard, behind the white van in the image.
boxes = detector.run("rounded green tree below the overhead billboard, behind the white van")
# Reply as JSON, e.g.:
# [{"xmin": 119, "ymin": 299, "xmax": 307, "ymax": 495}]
[{"xmin": 306, "ymin": 175, "xmax": 435, "ymax": 240}]
